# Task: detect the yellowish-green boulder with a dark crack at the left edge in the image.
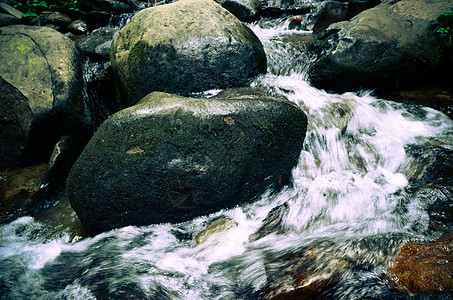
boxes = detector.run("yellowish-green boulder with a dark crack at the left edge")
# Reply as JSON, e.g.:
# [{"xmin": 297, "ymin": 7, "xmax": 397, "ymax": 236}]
[{"xmin": 0, "ymin": 25, "xmax": 92, "ymax": 164}]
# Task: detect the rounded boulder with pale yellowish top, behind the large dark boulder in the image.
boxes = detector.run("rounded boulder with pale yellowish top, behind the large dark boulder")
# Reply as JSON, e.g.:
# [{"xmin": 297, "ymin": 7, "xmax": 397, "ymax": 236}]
[{"xmin": 110, "ymin": 0, "xmax": 266, "ymax": 106}]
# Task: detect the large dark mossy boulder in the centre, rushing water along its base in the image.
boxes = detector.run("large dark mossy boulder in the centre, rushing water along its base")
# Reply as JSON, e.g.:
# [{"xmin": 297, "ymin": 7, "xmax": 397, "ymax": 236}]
[{"xmin": 66, "ymin": 88, "xmax": 307, "ymax": 235}]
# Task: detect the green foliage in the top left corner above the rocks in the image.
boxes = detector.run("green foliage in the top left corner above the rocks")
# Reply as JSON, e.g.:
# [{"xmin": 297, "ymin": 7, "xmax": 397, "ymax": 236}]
[{"xmin": 14, "ymin": 0, "xmax": 79, "ymax": 19}]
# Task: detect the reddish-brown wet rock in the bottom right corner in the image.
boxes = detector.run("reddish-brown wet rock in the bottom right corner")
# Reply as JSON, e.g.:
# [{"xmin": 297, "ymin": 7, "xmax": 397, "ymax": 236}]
[{"xmin": 387, "ymin": 233, "xmax": 453, "ymax": 293}]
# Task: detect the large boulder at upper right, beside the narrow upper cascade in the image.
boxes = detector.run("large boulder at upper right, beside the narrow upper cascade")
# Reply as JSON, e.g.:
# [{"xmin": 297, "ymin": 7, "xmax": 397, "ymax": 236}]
[{"xmin": 308, "ymin": 0, "xmax": 453, "ymax": 92}]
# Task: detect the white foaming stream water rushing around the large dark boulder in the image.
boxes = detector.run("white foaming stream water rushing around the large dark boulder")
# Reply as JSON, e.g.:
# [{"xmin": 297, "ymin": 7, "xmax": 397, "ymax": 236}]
[{"xmin": 0, "ymin": 8, "xmax": 453, "ymax": 299}]
